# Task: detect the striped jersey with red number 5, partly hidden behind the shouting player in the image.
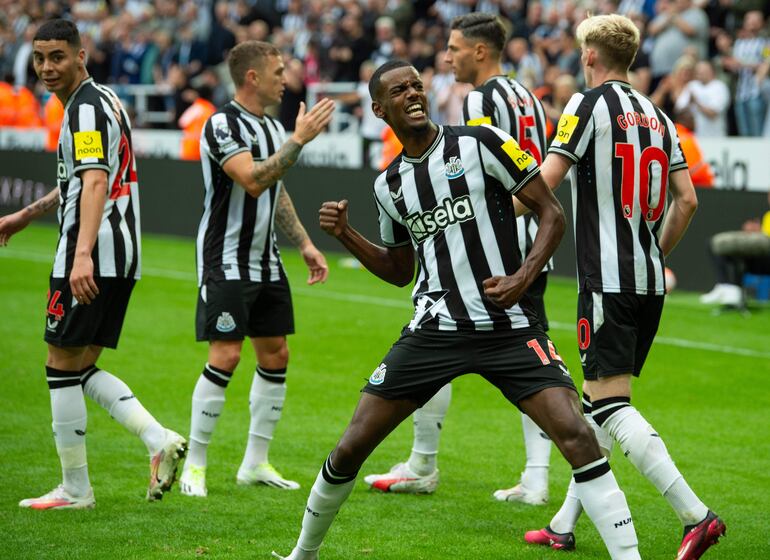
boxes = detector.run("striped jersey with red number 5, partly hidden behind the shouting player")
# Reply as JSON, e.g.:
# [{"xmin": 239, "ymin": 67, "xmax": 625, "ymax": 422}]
[{"xmin": 463, "ymin": 76, "xmax": 553, "ymax": 272}]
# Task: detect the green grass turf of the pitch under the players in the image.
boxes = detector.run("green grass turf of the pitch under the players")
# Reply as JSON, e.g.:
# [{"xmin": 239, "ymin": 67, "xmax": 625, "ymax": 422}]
[{"xmin": 0, "ymin": 227, "xmax": 770, "ymax": 560}]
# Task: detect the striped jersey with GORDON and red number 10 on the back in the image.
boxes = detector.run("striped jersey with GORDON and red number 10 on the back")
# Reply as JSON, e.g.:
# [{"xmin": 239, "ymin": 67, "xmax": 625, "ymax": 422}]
[{"xmin": 548, "ymin": 81, "xmax": 687, "ymax": 294}]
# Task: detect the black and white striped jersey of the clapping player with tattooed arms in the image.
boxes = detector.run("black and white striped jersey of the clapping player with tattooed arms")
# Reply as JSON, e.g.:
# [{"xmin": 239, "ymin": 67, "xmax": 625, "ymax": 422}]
[{"xmin": 196, "ymin": 101, "xmax": 286, "ymax": 285}]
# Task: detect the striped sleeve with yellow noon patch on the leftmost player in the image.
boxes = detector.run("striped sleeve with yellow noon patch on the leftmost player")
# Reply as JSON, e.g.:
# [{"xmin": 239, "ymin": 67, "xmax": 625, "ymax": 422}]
[{"xmin": 69, "ymin": 103, "xmax": 111, "ymax": 173}]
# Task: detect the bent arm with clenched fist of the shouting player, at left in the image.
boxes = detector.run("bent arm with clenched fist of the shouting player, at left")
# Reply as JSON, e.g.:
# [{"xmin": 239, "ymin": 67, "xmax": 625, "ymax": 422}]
[{"xmin": 319, "ymin": 200, "xmax": 414, "ymax": 287}]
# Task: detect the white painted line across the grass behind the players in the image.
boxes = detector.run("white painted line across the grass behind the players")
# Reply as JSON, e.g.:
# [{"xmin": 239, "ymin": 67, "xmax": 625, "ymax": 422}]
[{"xmin": 0, "ymin": 248, "xmax": 770, "ymax": 359}]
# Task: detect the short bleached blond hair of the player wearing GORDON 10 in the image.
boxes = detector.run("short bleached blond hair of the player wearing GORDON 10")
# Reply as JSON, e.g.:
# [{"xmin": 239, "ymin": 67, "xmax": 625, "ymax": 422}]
[{"xmin": 575, "ymin": 14, "xmax": 639, "ymax": 72}]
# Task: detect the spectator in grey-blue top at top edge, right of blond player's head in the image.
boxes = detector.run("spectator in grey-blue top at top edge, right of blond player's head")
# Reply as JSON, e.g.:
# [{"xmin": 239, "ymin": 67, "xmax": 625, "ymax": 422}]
[{"xmin": 647, "ymin": 0, "xmax": 709, "ymax": 88}]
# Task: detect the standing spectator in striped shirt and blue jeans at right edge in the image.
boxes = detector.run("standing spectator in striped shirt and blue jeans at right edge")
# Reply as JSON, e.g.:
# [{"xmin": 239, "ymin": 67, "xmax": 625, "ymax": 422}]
[{"xmin": 722, "ymin": 11, "xmax": 770, "ymax": 136}]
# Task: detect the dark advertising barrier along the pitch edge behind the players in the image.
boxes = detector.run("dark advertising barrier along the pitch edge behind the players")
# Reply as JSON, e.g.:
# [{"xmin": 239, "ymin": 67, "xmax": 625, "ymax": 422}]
[{"xmin": 0, "ymin": 149, "xmax": 768, "ymax": 290}]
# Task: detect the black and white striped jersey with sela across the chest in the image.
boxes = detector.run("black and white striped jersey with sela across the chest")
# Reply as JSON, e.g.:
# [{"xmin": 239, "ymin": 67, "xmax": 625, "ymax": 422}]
[{"xmin": 374, "ymin": 125, "xmax": 540, "ymax": 331}]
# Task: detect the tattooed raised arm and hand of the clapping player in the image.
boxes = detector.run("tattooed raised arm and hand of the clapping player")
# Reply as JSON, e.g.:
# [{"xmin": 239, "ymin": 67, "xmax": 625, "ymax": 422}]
[{"xmin": 222, "ymin": 99, "xmax": 334, "ymax": 198}]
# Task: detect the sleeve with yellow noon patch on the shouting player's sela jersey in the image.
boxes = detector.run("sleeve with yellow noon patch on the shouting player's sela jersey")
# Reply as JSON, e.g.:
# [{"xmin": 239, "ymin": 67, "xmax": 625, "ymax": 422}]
[{"xmin": 478, "ymin": 125, "xmax": 540, "ymax": 194}]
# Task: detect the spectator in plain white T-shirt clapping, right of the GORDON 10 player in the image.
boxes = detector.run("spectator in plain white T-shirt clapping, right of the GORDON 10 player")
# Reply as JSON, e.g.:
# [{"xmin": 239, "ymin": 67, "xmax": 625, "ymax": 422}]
[{"xmin": 675, "ymin": 60, "xmax": 730, "ymax": 137}]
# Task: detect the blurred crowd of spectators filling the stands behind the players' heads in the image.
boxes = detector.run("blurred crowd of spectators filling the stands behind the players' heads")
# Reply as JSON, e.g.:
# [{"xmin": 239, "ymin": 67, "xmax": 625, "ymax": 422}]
[{"xmin": 0, "ymin": 0, "xmax": 770, "ymax": 139}]
